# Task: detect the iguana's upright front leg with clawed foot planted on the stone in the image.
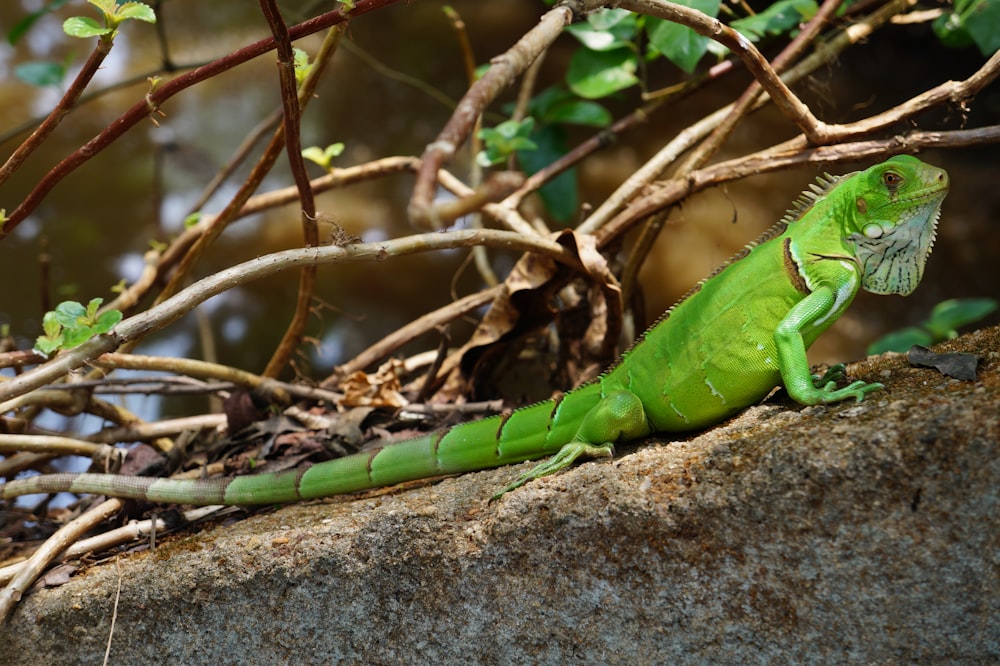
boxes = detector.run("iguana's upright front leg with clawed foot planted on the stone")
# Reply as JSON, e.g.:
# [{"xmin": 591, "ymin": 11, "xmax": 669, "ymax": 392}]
[{"xmin": 774, "ymin": 287, "xmax": 882, "ymax": 405}]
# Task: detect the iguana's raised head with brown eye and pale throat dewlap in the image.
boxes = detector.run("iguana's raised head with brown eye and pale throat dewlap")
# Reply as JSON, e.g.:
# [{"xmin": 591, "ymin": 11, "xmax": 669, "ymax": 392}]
[{"xmin": 846, "ymin": 155, "xmax": 948, "ymax": 296}]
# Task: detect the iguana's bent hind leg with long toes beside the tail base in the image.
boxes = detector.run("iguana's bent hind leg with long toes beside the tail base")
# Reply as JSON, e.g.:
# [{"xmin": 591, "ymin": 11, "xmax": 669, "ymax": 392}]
[{"xmin": 493, "ymin": 389, "xmax": 653, "ymax": 499}]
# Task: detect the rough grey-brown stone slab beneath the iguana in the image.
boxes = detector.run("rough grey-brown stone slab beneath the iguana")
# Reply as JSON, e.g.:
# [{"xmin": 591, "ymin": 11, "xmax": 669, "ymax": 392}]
[{"xmin": 0, "ymin": 329, "xmax": 1000, "ymax": 666}]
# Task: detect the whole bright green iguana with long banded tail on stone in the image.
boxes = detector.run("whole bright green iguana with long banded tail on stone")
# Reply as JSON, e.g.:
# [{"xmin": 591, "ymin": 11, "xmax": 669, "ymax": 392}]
[{"xmin": 0, "ymin": 155, "xmax": 948, "ymax": 504}]
